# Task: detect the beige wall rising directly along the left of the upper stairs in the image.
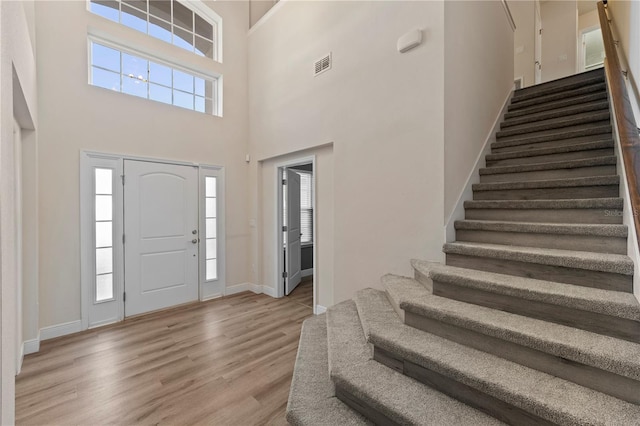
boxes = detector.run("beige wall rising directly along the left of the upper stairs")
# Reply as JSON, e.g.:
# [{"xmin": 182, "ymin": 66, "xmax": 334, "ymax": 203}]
[{"xmin": 444, "ymin": 1, "xmax": 514, "ymax": 218}]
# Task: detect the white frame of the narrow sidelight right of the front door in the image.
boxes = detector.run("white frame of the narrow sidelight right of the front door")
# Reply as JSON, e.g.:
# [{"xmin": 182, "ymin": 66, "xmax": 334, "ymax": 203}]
[{"xmin": 199, "ymin": 165, "xmax": 226, "ymax": 301}]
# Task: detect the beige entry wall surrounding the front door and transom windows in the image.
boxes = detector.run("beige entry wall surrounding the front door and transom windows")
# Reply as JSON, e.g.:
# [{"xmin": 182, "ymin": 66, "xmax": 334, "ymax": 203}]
[{"xmin": 36, "ymin": 1, "xmax": 250, "ymax": 328}]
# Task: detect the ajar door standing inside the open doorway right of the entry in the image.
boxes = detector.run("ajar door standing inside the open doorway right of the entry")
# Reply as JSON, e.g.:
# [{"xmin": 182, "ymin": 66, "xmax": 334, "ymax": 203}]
[{"xmin": 285, "ymin": 169, "xmax": 302, "ymax": 295}]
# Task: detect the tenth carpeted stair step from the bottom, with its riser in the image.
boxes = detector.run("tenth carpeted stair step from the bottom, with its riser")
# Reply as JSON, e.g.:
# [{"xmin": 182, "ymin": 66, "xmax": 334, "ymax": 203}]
[{"xmin": 480, "ymin": 156, "xmax": 618, "ymax": 183}]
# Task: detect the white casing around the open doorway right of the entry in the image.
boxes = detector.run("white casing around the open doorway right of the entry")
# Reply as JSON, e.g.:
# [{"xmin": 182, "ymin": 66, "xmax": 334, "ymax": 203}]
[{"xmin": 274, "ymin": 155, "xmax": 318, "ymax": 314}]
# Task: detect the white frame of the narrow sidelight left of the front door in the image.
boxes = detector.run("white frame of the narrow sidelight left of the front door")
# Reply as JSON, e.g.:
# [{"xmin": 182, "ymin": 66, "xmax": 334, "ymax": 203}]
[{"xmin": 80, "ymin": 152, "xmax": 124, "ymax": 330}]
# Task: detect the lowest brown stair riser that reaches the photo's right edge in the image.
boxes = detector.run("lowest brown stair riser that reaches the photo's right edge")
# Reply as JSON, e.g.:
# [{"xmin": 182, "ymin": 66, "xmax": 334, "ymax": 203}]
[{"xmin": 405, "ymin": 312, "xmax": 640, "ymax": 404}]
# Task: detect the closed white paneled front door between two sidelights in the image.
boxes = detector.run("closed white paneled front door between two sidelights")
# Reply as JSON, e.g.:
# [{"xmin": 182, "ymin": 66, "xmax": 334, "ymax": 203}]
[{"xmin": 124, "ymin": 160, "xmax": 199, "ymax": 316}]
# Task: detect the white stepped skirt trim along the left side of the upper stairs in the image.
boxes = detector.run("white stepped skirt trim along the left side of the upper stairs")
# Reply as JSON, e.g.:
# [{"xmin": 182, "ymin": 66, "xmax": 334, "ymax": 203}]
[{"xmin": 444, "ymin": 91, "xmax": 514, "ymax": 243}]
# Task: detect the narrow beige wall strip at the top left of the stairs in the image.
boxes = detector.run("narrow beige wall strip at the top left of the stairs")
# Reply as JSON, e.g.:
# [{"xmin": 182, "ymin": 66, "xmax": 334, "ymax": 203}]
[{"xmin": 509, "ymin": 0, "xmax": 536, "ymax": 87}]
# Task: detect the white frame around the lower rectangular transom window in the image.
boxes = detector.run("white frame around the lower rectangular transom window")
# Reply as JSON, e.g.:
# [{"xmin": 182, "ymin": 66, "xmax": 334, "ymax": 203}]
[{"xmin": 87, "ymin": 28, "xmax": 223, "ymax": 117}]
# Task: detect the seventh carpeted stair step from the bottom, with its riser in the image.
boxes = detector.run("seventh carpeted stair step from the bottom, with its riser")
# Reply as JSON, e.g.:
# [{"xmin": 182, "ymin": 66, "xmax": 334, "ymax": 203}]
[{"xmin": 454, "ymin": 220, "xmax": 628, "ymax": 254}]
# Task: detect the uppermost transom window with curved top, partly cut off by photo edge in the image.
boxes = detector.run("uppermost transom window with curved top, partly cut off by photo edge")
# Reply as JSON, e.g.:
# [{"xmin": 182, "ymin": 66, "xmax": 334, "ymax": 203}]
[{"xmin": 89, "ymin": 0, "xmax": 220, "ymax": 61}]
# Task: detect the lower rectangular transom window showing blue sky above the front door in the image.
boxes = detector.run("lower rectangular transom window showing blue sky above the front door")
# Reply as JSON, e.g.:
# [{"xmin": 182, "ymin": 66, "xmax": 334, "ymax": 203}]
[{"xmin": 89, "ymin": 41, "xmax": 218, "ymax": 115}]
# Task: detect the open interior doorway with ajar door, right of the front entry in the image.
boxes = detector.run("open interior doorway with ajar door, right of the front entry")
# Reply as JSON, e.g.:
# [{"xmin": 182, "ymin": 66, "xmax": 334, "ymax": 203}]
[{"xmin": 277, "ymin": 159, "xmax": 315, "ymax": 307}]
